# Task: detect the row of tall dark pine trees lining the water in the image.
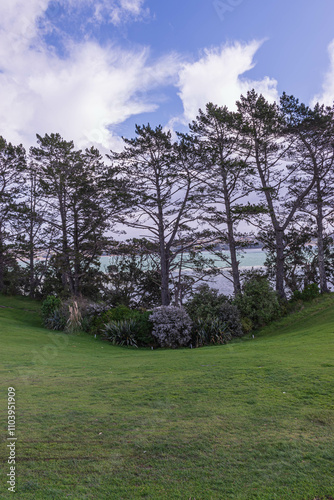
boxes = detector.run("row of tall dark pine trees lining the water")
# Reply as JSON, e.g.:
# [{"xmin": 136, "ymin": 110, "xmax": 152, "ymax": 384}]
[{"xmin": 0, "ymin": 90, "xmax": 334, "ymax": 305}]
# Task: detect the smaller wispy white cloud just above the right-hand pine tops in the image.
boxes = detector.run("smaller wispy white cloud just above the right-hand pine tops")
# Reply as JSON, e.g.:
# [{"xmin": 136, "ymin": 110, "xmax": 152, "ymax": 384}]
[{"xmin": 178, "ymin": 41, "xmax": 278, "ymax": 121}]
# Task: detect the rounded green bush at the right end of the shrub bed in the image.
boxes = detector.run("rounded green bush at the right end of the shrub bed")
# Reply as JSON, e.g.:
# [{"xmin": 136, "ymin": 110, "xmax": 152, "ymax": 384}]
[{"xmin": 234, "ymin": 272, "xmax": 282, "ymax": 328}]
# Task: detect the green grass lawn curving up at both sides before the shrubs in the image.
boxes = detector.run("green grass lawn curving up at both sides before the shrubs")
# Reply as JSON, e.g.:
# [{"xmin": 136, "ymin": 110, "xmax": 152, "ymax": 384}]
[{"xmin": 0, "ymin": 295, "xmax": 334, "ymax": 500}]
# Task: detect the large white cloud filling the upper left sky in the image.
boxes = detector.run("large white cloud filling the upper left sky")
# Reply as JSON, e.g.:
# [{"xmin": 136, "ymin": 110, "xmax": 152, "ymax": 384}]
[{"xmin": 0, "ymin": 0, "xmax": 178, "ymax": 149}]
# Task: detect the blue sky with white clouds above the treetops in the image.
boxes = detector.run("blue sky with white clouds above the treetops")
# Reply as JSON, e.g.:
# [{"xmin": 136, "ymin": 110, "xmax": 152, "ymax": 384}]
[{"xmin": 0, "ymin": 0, "xmax": 334, "ymax": 151}]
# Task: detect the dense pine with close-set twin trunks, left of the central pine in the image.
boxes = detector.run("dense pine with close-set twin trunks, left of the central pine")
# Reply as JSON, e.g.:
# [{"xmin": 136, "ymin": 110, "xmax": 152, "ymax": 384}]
[{"xmin": 30, "ymin": 134, "xmax": 112, "ymax": 297}]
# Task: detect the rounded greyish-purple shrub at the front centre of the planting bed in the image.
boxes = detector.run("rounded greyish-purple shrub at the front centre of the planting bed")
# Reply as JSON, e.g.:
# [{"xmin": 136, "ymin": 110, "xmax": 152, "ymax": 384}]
[{"xmin": 149, "ymin": 306, "xmax": 192, "ymax": 348}]
